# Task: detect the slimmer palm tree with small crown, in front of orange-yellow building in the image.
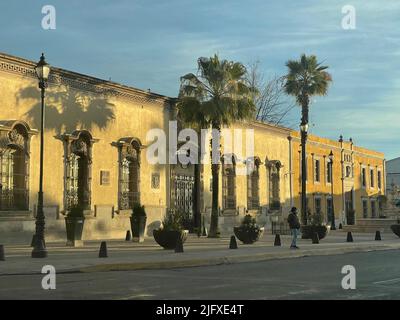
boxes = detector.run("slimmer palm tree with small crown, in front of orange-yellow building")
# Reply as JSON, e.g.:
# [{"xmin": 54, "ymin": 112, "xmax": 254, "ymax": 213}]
[{"xmin": 285, "ymin": 54, "xmax": 332, "ymax": 224}]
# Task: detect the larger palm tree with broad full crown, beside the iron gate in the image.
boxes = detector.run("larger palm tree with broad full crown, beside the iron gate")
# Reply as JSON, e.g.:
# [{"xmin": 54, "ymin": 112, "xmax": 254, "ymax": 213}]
[{"xmin": 178, "ymin": 55, "xmax": 255, "ymax": 237}]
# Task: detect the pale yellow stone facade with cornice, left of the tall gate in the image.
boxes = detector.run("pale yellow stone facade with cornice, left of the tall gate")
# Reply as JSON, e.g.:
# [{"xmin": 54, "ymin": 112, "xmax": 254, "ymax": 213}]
[{"xmin": 0, "ymin": 54, "xmax": 173, "ymax": 239}]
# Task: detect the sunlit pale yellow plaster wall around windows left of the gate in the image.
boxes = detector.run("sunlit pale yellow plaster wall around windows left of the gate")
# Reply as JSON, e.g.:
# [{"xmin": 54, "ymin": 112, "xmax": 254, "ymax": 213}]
[{"xmin": 0, "ymin": 60, "xmax": 169, "ymax": 222}]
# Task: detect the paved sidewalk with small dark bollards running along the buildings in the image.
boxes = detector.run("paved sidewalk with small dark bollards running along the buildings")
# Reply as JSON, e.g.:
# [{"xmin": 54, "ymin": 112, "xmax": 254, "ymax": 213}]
[{"xmin": 0, "ymin": 231, "xmax": 400, "ymax": 277}]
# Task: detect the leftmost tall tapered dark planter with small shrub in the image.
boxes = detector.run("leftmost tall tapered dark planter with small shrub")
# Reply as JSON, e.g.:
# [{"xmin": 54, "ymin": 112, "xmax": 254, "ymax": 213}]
[{"xmin": 65, "ymin": 205, "xmax": 85, "ymax": 247}]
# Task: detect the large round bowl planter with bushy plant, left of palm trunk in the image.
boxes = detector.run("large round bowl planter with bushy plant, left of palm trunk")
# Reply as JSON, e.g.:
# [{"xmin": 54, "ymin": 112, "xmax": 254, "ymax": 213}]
[{"xmin": 153, "ymin": 210, "xmax": 189, "ymax": 250}]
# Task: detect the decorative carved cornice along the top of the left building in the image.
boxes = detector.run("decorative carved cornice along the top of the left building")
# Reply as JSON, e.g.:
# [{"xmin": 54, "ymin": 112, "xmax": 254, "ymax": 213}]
[{"xmin": 0, "ymin": 53, "xmax": 175, "ymax": 107}]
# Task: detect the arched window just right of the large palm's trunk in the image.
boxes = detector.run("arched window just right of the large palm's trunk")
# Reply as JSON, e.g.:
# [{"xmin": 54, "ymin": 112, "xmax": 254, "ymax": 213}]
[{"xmin": 222, "ymin": 155, "xmax": 236, "ymax": 210}]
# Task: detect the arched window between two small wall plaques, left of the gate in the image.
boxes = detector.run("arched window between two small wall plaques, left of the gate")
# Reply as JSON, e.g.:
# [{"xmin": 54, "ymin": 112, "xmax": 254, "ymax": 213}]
[{"xmin": 112, "ymin": 137, "xmax": 142, "ymax": 210}]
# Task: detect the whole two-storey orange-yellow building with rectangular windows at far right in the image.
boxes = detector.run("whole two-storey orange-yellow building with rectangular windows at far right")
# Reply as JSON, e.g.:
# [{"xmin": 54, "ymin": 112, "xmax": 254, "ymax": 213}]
[{"xmin": 291, "ymin": 131, "xmax": 385, "ymax": 224}]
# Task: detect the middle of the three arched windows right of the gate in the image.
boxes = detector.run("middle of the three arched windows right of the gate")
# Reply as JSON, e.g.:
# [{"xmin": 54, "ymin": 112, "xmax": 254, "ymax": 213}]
[{"xmin": 247, "ymin": 157, "xmax": 261, "ymax": 210}]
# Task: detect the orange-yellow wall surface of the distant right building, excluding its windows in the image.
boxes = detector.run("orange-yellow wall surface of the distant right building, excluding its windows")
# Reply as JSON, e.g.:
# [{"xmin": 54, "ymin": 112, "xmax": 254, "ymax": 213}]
[{"xmin": 291, "ymin": 131, "xmax": 385, "ymax": 221}]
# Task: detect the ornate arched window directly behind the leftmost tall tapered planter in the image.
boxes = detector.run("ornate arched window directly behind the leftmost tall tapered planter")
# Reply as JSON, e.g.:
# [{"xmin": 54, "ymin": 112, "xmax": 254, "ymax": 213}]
[{"xmin": 58, "ymin": 130, "xmax": 97, "ymax": 210}]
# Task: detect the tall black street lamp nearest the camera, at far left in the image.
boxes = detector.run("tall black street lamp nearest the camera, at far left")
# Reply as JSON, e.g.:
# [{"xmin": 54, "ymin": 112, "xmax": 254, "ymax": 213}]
[{"xmin": 32, "ymin": 53, "xmax": 50, "ymax": 258}]
